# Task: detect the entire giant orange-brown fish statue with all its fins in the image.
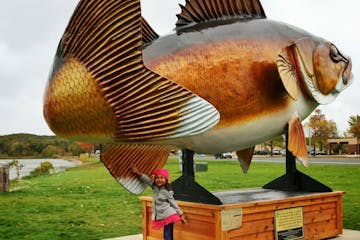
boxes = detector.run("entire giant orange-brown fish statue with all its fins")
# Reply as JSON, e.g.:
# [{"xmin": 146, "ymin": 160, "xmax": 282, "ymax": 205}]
[{"xmin": 44, "ymin": 0, "xmax": 351, "ymax": 193}]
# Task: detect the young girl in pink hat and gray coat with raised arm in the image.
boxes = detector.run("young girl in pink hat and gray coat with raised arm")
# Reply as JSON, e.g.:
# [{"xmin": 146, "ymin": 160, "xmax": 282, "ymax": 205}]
[{"xmin": 131, "ymin": 166, "xmax": 185, "ymax": 240}]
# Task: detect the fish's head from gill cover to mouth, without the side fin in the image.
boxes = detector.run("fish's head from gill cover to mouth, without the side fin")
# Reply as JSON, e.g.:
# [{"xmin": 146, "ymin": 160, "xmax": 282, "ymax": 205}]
[{"xmin": 294, "ymin": 38, "xmax": 352, "ymax": 104}]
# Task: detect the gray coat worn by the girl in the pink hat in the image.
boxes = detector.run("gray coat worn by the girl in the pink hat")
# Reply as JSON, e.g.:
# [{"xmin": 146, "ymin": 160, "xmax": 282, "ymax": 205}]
[{"xmin": 140, "ymin": 174, "xmax": 183, "ymax": 220}]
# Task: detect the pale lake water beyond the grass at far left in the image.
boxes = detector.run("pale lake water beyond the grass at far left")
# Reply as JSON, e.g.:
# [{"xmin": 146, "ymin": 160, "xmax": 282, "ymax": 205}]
[{"xmin": 0, "ymin": 159, "xmax": 79, "ymax": 180}]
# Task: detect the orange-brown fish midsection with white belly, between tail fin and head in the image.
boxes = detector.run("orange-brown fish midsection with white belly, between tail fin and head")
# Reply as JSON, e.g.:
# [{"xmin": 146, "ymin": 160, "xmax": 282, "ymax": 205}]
[{"xmin": 143, "ymin": 19, "xmax": 317, "ymax": 153}]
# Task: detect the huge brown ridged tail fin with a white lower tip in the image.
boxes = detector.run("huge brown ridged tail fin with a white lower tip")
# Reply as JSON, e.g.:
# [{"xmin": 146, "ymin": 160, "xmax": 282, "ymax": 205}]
[{"xmin": 52, "ymin": 0, "xmax": 220, "ymax": 142}]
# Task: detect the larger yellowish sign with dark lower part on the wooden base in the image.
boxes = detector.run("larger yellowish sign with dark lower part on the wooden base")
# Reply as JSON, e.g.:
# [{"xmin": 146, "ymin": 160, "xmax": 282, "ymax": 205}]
[{"xmin": 275, "ymin": 207, "xmax": 304, "ymax": 240}]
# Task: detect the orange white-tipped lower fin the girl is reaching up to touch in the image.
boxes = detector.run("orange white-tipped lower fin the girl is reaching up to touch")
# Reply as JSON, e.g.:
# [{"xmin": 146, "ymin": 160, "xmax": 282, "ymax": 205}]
[{"xmin": 101, "ymin": 144, "xmax": 171, "ymax": 194}]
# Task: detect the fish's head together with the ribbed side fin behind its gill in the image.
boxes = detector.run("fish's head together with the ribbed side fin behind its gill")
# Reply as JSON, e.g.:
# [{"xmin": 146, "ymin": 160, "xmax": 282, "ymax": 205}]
[{"xmin": 277, "ymin": 38, "xmax": 352, "ymax": 104}]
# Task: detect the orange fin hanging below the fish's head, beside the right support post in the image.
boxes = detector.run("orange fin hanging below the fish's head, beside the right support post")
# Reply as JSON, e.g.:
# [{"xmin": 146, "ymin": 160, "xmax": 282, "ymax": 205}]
[{"xmin": 288, "ymin": 117, "xmax": 309, "ymax": 167}]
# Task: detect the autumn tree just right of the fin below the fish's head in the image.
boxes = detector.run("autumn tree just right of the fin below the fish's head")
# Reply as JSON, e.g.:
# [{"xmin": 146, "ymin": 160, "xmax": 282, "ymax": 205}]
[{"xmin": 306, "ymin": 109, "xmax": 338, "ymax": 152}]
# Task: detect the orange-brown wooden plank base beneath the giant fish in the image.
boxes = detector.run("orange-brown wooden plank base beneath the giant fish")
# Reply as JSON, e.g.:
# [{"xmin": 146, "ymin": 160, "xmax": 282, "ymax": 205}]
[{"xmin": 140, "ymin": 189, "xmax": 344, "ymax": 240}]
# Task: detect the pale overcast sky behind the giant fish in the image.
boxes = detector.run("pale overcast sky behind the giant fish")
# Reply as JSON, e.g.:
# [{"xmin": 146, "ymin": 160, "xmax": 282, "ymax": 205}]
[{"xmin": 0, "ymin": 0, "xmax": 360, "ymax": 135}]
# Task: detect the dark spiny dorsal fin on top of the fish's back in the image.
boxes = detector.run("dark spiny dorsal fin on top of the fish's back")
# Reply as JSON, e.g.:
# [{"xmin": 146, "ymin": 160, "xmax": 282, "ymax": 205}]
[{"xmin": 176, "ymin": 0, "xmax": 266, "ymax": 28}]
